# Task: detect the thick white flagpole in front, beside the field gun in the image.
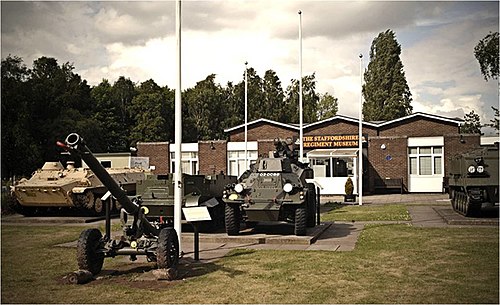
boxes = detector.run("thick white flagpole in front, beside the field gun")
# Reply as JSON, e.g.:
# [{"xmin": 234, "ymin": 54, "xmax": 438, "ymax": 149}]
[{"xmin": 174, "ymin": 0, "xmax": 184, "ymax": 253}]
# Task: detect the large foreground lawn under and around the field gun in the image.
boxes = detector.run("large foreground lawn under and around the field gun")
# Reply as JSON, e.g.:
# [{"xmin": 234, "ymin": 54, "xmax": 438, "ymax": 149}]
[{"xmin": 1, "ymin": 224, "xmax": 499, "ymax": 304}]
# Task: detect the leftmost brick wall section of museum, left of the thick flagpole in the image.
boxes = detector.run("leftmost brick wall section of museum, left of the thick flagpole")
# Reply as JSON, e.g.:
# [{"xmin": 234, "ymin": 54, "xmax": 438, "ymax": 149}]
[{"xmin": 137, "ymin": 142, "xmax": 170, "ymax": 174}]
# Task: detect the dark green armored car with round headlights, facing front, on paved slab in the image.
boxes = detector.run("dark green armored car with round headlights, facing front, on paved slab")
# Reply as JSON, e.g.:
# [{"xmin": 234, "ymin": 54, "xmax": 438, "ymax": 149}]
[{"xmin": 222, "ymin": 138, "xmax": 317, "ymax": 235}]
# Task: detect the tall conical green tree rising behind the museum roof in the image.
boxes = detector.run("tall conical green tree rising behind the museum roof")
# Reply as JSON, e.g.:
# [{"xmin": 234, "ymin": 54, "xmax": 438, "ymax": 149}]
[{"xmin": 362, "ymin": 30, "xmax": 413, "ymax": 121}]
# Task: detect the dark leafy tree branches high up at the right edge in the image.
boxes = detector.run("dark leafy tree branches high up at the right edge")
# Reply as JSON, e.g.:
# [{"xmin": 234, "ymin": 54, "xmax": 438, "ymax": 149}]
[{"xmin": 474, "ymin": 32, "xmax": 500, "ymax": 81}]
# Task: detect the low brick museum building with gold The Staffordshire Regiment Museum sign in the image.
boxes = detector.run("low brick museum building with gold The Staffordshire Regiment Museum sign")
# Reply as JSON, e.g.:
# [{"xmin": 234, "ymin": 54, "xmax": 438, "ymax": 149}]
[{"xmin": 137, "ymin": 113, "xmax": 498, "ymax": 195}]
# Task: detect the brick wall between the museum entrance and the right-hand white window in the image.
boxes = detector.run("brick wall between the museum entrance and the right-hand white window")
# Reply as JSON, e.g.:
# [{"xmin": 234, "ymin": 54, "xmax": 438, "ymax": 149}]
[{"xmin": 368, "ymin": 137, "xmax": 408, "ymax": 192}]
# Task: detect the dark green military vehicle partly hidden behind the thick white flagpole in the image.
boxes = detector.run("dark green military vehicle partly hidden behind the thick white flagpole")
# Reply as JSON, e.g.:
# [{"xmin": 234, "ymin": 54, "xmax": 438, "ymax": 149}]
[{"xmin": 137, "ymin": 174, "xmax": 237, "ymax": 231}]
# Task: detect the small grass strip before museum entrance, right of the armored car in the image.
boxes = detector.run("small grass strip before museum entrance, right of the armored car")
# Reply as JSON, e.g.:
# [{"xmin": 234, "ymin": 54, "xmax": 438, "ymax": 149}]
[{"xmin": 321, "ymin": 203, "xmax": 411, "ymax": 221}]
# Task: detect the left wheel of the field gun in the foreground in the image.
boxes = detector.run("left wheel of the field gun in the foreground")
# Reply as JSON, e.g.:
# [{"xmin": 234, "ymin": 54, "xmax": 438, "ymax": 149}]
[{"xmin": 76, "ymin": 229, "xmax": 104, "ymax": 275}]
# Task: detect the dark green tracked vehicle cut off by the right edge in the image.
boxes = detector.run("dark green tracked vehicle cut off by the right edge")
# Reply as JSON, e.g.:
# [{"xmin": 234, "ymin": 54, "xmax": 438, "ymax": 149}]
[{"xmin": 448, "ymin": 143, "xmax": 499, "ymax": 217}]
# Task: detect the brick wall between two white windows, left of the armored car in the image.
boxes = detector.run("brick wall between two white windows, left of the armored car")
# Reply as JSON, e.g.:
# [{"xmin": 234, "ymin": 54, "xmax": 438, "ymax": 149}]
[{"xmin": 198, "ymin": 140, "xmax": 227, "ymax": 175}]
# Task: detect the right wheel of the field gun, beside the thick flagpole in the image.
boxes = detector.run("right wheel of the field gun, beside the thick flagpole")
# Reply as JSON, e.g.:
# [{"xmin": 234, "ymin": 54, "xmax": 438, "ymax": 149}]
[{"xmin": 156, "ymin": 228, "xmax": 179, "ymax": 269}]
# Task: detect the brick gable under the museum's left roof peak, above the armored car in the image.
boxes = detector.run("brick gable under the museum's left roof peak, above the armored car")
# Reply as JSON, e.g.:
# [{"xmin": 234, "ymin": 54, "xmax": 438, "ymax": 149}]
[{"xmin": 229, "ymin": 123, "xmax": 299, "ymax": 142}]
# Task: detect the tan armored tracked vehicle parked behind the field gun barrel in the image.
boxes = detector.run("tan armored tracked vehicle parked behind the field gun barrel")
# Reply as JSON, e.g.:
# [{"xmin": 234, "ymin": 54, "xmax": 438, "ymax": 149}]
[{"xmin": 11, "ymin": 162, "xmax": 145, "ymax": 216}]
